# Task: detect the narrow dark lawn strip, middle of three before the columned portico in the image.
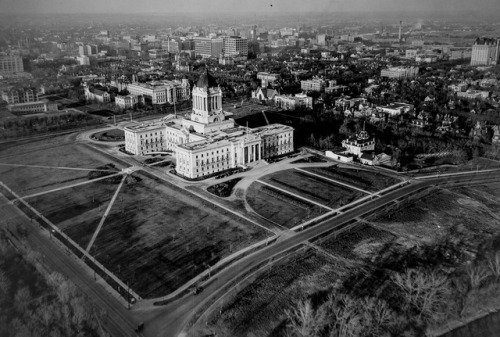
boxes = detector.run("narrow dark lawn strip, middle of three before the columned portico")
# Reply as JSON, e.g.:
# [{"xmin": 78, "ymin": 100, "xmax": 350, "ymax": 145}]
[{"xmin": 261, "ymin": 170, "xmax": 365, "ymax": 208}]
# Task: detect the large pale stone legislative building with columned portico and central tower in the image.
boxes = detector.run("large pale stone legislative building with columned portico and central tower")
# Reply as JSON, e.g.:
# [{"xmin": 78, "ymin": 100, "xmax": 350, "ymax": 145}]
[{"xmin": 125, "ymin": 70, "xmax": 294, "ymax": 179}]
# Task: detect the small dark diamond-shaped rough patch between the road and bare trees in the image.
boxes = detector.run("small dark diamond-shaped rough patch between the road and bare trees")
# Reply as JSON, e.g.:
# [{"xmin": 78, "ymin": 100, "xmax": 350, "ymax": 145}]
[{"xmin": 316, "ymin": 223, "xmax": 396, "ymax": 260}]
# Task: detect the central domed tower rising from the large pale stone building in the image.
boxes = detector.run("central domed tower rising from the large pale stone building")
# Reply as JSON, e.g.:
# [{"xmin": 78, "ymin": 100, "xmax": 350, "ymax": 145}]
[{"xmin": 191, "ymin": 69, "xmax": 225, "ymax": 124}]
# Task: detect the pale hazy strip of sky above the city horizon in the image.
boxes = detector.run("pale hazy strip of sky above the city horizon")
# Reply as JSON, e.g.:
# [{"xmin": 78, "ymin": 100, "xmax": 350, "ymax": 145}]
[{"xmin": 0, "ymin": 0, "xmax": 500, "ymax": 14}]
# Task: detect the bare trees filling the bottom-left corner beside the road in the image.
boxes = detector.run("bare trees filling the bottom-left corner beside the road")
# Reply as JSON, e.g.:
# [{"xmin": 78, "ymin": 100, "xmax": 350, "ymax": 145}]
[{"xmin": 0, "ymin": 231, "xmax": 109, "ymax": 337}]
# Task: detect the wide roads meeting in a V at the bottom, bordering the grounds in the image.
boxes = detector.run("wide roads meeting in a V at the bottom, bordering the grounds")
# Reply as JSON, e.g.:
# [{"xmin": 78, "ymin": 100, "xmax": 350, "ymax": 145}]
[{"xmin": 0, "ymin": 126, "xmax": 500, "ymax": 337}]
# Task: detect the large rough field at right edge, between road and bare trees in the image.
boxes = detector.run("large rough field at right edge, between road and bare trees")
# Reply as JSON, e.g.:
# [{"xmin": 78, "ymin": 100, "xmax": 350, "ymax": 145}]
[{"xmin": 368, "ymin": 183, "xmax": 500, "ymax": 249}]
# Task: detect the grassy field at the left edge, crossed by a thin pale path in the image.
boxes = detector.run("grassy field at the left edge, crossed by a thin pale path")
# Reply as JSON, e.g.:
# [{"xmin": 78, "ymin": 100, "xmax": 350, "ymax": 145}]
[{"xmin": 0, "ymin": 144, "xmax": 121, "ymax": 196}]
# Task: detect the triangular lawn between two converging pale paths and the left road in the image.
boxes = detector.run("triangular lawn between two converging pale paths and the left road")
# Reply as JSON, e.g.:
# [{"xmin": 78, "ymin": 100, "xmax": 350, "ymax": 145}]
[{"xmin": 27, "ymin": 181, "xmax": 118, "ymax": 249}]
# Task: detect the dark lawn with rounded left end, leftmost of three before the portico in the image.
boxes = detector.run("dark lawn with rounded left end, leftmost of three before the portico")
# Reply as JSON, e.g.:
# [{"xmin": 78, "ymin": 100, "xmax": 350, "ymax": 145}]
[{"xmin": 246, "ymin": 182, "xmax": 326, "ymax": 228}]
